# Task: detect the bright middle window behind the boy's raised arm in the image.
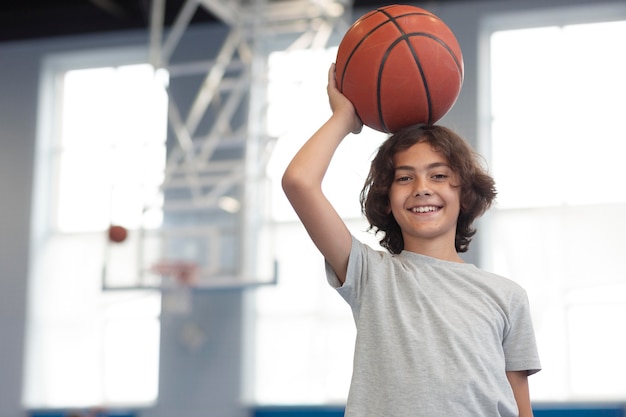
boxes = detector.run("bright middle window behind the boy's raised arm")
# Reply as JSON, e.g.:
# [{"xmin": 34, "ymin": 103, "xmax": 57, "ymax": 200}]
[{"xmin": 254, "ymin": 49, "xmax": 386, "ymax": 404}]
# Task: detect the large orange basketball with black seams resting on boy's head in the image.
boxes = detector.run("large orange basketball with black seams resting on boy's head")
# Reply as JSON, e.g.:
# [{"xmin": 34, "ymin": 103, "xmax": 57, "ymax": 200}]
[{"xmin": 335, "ymin": 5, "xmax": 463, "ymax": 133}]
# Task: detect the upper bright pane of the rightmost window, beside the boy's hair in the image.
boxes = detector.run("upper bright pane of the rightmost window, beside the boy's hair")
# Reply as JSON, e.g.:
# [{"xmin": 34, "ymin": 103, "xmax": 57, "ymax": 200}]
[{"xmin": 491, "ymin": 21, "xmax": 626, "ymax": 208}]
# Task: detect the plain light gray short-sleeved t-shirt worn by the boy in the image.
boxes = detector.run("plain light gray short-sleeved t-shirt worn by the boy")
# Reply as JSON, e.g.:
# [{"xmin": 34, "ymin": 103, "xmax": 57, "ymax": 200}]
[{"xmin": 326, "ymin": 237, "xmax": 541, "ymax": 417}]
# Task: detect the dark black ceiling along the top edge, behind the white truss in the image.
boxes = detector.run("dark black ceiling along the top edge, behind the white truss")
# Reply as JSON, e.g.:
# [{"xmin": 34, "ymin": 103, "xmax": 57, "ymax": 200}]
[{"xmin": 0, "ymin": 0, "xmax": 389, "ymax": 42}]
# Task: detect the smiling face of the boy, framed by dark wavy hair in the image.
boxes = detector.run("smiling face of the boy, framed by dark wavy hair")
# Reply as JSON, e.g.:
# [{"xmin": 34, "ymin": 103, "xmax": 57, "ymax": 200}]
[{"xmin": 389, "ymin": 142, "xmax": 461, "ymax": 252}]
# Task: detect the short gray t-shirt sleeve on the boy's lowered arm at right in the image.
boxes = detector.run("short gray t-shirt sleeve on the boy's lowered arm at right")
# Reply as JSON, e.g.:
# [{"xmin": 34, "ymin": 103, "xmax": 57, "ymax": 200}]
[{"xmin": 503, "ymin": 289, "xmax": 541, "ymax": 375}]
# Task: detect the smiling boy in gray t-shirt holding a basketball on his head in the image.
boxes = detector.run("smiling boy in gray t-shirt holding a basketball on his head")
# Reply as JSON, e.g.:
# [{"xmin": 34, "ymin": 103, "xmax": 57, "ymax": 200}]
[{"xmin": 283, "ymin": 66, "xmax": 540, "ymax": 417}]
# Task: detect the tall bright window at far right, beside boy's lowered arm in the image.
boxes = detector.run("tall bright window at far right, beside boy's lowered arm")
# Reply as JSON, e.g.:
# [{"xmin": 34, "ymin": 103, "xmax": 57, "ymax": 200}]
[{"xmin": 482, "ymin": 16, "xmax": 626, "ymax": 401}]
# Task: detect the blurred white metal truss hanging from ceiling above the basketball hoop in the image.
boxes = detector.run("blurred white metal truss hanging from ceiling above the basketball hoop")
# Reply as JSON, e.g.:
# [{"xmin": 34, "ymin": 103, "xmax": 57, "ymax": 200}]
[{"xmin": 150, "ymin": 0, "xmax": 349, "ymax": 209}]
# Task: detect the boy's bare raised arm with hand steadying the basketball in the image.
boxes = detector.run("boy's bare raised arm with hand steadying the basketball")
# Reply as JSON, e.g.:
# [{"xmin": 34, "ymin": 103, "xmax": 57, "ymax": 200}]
[{"xmin": 282, "ymin": 65, "xmax": 362, "ymax": 282}]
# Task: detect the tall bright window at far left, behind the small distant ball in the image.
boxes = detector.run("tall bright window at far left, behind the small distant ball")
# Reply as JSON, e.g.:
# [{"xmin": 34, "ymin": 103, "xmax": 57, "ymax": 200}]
[{"xmin": 24, "ymin": 54, "xmax": 167, "ymax": 408}]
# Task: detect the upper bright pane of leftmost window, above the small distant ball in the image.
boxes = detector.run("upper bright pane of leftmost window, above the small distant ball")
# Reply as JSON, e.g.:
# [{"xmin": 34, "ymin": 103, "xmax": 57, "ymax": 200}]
[{"xmin": 57, "ymin": 64, "xmax": 167, "ymax": 232}]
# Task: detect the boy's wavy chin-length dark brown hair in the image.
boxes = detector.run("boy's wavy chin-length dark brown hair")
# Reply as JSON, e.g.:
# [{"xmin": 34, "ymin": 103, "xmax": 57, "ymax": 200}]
[{"xmin": 360, "ymin": 125, "xmax": 497, "ymax": 254}]
